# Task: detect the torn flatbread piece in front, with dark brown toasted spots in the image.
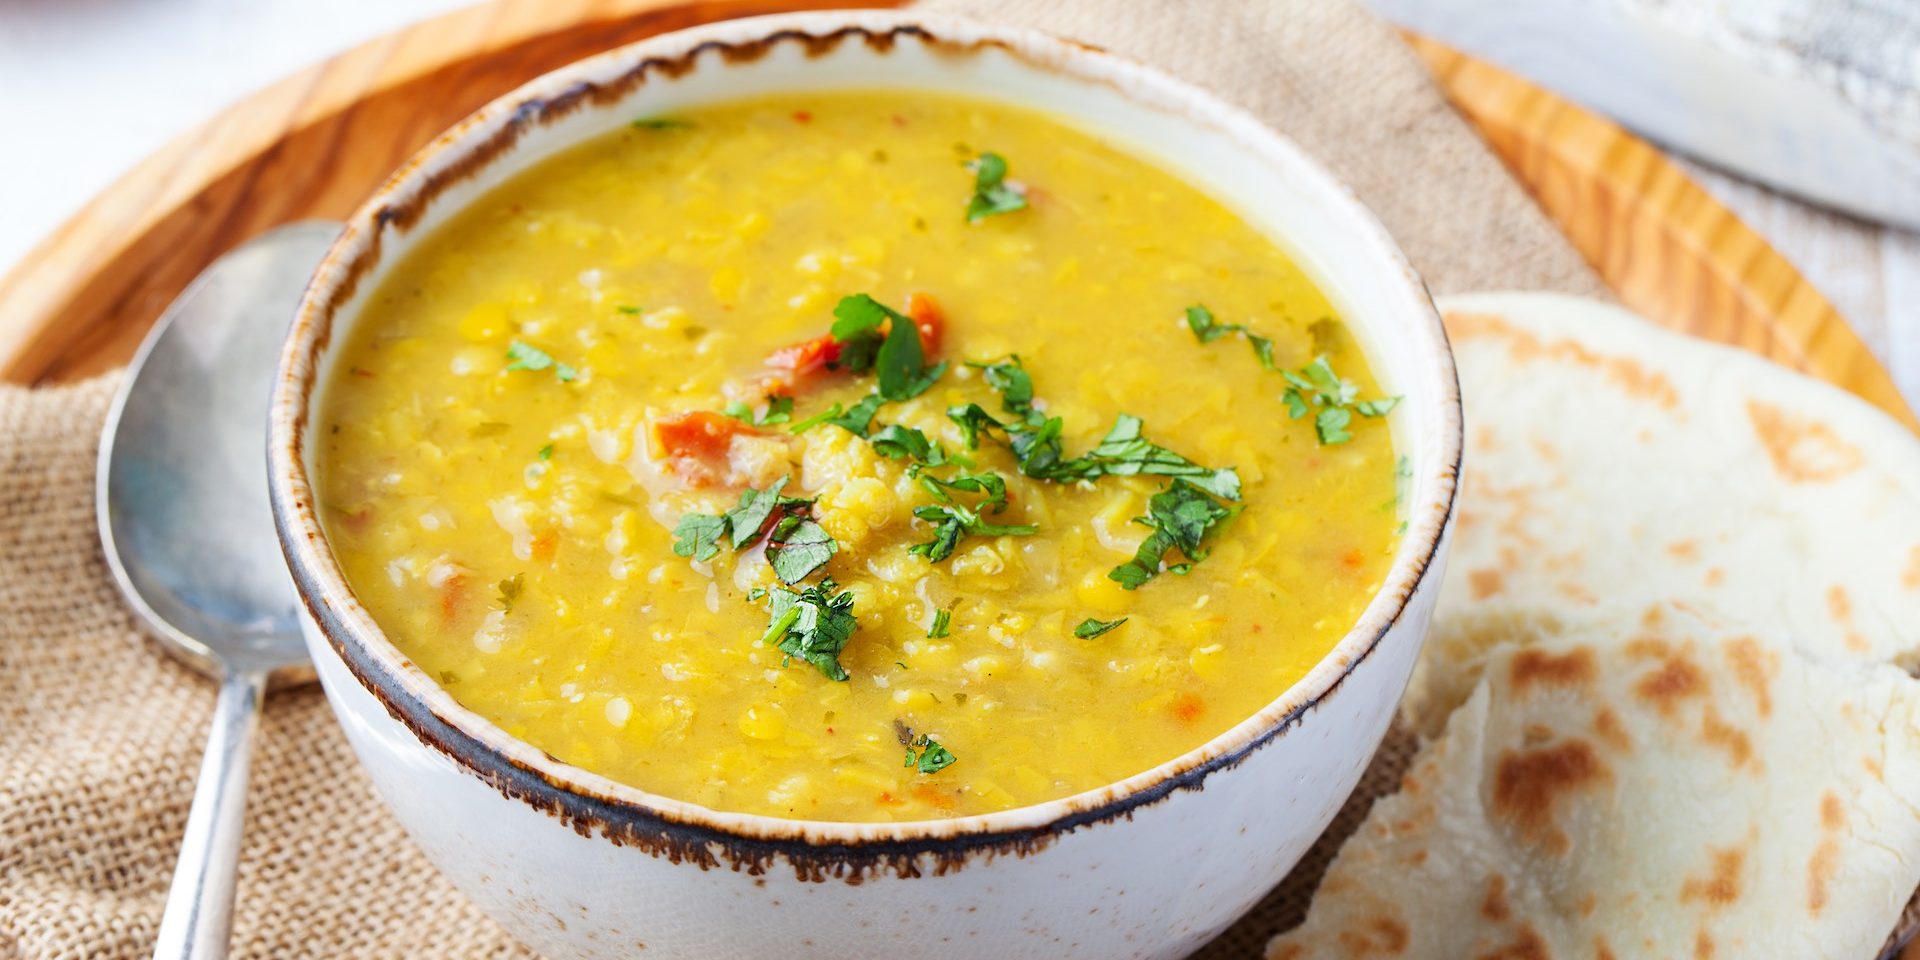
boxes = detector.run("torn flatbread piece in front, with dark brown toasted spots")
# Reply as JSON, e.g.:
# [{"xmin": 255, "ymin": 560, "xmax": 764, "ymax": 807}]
[{"xmin": 1267, "ymin": 605, "xmax": 1920, "ymax": 960}]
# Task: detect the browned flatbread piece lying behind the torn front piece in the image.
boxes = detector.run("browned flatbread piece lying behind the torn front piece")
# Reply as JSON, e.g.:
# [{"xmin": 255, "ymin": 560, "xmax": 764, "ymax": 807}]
[{"xmin": 1407, "ymin": 294, "xmax": 1920, "ymax": 735}]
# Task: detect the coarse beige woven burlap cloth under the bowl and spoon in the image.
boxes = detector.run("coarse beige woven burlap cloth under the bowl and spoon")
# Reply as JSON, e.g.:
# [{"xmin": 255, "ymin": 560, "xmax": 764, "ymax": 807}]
[{"xmin": 0, "ymin": 0, "xmax": 1605, "ymax": 958}]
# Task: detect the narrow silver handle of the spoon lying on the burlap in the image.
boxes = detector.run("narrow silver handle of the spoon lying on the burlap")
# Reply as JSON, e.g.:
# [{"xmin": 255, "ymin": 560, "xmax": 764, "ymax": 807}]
[{"xmin": 154, "ymin": 670, "xmax": 267, "ymax": 960}]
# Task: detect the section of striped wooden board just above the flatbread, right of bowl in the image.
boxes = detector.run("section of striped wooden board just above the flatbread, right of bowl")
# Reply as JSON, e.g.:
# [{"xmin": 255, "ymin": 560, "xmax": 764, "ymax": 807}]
[{"xmin": 1407, "ymin": 36, "xmax": 1920, "ymax": 430}]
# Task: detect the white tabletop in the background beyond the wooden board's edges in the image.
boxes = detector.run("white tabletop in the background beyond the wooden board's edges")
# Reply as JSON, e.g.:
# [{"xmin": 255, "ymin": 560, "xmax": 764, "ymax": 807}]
[{"xmin": 0, "ymin": 0, "xmax": 1920, "ymax": 407}]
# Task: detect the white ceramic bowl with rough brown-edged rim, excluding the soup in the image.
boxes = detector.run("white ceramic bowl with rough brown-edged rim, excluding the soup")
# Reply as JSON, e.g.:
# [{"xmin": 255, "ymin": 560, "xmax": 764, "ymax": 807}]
[{"xmin": 269, "ymin": 12, "xmax": 1461, "ymax": 960}]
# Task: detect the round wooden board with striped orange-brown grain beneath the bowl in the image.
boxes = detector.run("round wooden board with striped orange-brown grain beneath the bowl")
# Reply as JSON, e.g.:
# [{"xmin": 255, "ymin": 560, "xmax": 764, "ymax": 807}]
[{"xmin": 0, "ymin": 0, "xmax": 1916, "ymax": 435}]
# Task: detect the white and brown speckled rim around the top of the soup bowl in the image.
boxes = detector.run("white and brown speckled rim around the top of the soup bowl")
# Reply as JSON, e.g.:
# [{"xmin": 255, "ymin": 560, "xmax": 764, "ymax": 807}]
[{"xmin": 267, "ymin": 12, "xmax": 1461, "ymax": 883}]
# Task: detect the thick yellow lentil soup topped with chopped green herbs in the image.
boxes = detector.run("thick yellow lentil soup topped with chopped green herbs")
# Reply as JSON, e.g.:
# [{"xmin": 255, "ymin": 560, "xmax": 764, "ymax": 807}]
[{"xmin": 319, "ymin": 94, "xmax": 1400, "ymax": 820}]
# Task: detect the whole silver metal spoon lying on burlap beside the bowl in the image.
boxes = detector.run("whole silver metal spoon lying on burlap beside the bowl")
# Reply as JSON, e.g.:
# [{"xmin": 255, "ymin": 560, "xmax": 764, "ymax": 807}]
[{"xmin": 96, "ymin": 223, "xmax": 340, "ymax": 960}]
